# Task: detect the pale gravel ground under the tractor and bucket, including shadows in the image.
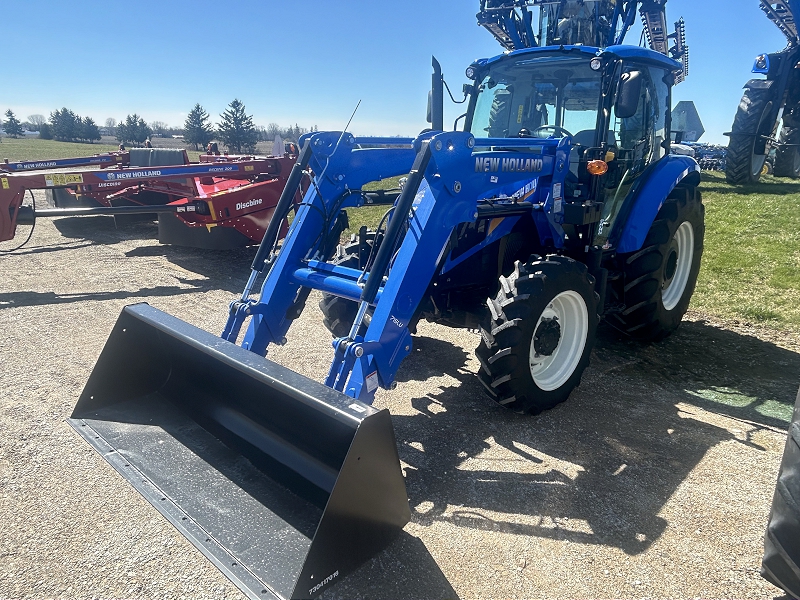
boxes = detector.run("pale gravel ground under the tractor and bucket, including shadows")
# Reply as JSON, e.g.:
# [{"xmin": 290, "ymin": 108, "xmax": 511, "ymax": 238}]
[{"xmin": 0, "ymin": 204, "xmax": 800, "ymax": 600}]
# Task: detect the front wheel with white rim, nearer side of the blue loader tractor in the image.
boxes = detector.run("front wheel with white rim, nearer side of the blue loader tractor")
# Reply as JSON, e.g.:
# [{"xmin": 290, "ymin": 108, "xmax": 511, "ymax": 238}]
[{"xmin": 475, "ymin": 256, "xmax": 599, "ymax": 414}]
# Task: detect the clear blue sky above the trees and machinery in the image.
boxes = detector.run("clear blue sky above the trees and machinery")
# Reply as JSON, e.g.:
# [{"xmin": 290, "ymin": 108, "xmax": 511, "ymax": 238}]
[{"xmin": 0, "ymin": 0, "xmax": 785, "ymax": 143}]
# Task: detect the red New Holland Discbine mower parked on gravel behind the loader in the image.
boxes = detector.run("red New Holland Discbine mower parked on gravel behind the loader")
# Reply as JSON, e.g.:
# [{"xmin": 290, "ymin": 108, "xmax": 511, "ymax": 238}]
[{"xmin": 0, "ymin": 149, "xmax": 299, "ymax": 249}]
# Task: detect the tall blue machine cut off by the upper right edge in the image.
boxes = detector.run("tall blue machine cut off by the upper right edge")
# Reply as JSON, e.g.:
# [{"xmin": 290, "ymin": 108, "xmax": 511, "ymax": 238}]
[{"xmin": 725, "ymin": 0, "xmax": 800, "ymax": 184}]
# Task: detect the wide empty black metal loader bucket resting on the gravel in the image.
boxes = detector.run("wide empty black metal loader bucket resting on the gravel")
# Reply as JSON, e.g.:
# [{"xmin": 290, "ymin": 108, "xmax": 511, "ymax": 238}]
[{"xmin": 69, "ymin": 304, "xmax": 410, "ymax": 599}]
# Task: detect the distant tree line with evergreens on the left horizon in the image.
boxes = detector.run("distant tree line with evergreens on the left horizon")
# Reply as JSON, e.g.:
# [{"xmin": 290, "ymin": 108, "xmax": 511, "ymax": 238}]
[{"xmin": 0, "ymin": 98, "xmax": 318, "ymax": 154}]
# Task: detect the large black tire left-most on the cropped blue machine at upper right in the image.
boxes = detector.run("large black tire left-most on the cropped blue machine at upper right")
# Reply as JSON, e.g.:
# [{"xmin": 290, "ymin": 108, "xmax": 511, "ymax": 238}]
[{"xmin": 725, "ymin": 89, "xmax": 775, "ymax": 185}]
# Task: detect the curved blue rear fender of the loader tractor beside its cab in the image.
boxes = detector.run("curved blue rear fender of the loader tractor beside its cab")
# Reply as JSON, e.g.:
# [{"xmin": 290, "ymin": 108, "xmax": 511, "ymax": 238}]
[{"xmin": 611, "ymin": 155, "xmax": 700, "ymax": 253}]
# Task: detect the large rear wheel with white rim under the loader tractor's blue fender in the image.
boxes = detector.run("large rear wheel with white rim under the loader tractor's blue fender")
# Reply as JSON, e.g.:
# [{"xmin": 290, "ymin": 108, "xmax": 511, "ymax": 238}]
[{"xmin": 608, "ymin": 188, "xmax": 705, "ymax": 341}]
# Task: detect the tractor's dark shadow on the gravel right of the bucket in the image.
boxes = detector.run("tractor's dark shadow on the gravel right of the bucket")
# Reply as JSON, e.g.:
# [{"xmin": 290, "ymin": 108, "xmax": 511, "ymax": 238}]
[{"xmin": 378, "ymin": 322, "xmax": 800, "ymax": 555}]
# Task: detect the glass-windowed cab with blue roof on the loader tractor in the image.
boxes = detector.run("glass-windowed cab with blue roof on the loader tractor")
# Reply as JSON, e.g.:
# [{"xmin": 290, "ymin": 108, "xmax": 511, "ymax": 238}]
[{"xmin": 465, "ymin": 46, "xmax": 680, "ymax": 246}]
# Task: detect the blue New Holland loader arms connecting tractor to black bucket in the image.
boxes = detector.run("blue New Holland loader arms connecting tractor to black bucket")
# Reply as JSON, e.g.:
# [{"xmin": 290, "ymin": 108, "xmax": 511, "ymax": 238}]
[{"xmin": 223, "ymin": 132, "xmax": 569, "ymax": 404}]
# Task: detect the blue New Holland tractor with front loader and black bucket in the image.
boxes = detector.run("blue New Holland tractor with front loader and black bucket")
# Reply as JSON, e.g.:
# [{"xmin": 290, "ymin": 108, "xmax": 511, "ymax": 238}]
[{"xmin": 70, "ymin": 0, "xmax": 704, "ymax": 598}]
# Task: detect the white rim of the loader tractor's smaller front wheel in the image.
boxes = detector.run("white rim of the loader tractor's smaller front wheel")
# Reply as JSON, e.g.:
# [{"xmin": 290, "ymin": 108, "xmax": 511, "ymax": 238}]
[{"xmin": 529, "ymin": 291, "xmax": 589, "ymax": 392}]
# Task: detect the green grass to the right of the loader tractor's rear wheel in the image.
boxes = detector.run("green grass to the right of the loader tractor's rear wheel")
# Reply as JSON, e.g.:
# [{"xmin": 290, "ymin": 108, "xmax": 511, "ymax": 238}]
[{"xmin": 692, "ymin": 172, "xmax": 800, "ymax": 330}]
